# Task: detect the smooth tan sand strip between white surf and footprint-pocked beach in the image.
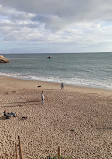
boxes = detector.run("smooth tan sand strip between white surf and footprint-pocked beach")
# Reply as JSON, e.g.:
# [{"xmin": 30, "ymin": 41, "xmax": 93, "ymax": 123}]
[{"xmin": 0, "ymin": 76, "xmax": 112, "ymax": 95}]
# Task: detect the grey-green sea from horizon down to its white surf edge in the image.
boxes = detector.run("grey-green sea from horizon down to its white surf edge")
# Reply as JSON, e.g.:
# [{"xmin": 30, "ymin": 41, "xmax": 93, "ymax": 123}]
[{"xmin": 0, "ymin": 52, "xmax": 112, "ymax": 90}]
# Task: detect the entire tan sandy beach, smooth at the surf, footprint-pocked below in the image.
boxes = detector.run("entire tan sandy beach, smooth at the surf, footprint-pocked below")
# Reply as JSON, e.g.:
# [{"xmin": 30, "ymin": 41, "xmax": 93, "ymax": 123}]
[{"xmin": 0, "ymin": 77, "xmax": 112, "ymax": 159}]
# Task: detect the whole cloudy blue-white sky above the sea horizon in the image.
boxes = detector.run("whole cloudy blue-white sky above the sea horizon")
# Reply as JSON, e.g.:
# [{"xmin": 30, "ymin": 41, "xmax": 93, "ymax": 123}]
[{"xmin": 0, "ymin": 0, "xmax": 112, "ymax": 54}]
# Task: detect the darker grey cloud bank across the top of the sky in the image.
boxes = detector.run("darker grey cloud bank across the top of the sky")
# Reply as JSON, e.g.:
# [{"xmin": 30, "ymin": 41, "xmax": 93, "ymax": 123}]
[{"xmin": 0, "ymin": 0, "xmax": 112, "ymax": 22}]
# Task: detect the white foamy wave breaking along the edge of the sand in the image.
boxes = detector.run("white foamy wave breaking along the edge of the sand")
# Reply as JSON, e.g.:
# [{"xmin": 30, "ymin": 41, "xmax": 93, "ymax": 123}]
[{"xmin": 0, "ymin": 73, "xmax": 112, "ymax": 90}]
